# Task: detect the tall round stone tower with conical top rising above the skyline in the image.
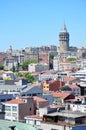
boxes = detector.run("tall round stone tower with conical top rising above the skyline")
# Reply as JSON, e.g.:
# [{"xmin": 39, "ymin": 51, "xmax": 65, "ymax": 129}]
[{"xmin": 59, "ymin": 24, "xmax": 69, "ymax": 52}]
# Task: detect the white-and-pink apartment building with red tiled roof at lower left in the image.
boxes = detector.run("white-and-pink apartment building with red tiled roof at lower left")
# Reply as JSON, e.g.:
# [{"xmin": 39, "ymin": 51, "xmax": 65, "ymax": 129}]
[{"xmin": 3, "ymin": 96, "xmax": 34, "ymax": 121}]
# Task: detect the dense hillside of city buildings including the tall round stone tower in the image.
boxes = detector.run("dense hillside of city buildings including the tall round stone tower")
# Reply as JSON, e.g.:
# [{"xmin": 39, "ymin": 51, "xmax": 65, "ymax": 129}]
[{"xmin": 0, "ymin": 25, "xmax": 86, "ymax": 130}]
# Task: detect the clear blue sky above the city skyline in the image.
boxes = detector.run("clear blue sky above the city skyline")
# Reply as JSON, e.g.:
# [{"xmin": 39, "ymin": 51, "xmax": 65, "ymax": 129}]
[{"xmin": 0, "ymin": 0, "xmax": 86, "ymax": 51}]
